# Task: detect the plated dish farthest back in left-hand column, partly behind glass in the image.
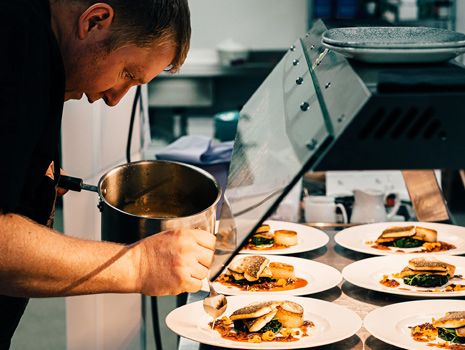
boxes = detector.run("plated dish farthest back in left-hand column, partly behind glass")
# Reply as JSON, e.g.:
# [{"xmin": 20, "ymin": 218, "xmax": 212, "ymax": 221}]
[{"xmin": 241, "ymin": 220, "xmax": 329, "ymax": 255}]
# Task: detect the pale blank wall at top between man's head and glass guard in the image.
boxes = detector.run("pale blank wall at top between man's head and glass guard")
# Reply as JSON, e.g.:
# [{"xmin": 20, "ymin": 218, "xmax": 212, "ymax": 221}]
[{"xmin": 189, "ymin": 0, "xmax": 309, "ymax": 49}]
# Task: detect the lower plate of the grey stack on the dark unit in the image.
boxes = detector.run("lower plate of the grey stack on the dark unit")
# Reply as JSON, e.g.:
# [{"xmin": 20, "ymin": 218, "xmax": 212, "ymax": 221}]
[{"xmin": 322, "ymin": 42, "xmax": 465, "ymax": 63}]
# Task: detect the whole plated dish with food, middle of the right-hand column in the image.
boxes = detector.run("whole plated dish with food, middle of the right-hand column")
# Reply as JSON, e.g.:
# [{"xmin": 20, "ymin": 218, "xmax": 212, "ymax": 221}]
[{"xmin": 342, "ymin": 254, "xmax": 465, "ymax": 298}]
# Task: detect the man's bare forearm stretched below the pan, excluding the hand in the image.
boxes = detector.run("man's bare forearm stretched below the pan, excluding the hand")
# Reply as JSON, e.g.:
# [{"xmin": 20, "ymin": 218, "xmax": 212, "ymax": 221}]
[{"xmin": 0, "ymin": 214, "xmax": 140, "ymax": 297}]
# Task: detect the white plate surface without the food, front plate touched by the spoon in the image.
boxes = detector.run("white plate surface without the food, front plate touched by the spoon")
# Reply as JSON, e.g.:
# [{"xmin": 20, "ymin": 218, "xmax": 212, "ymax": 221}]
[{"xmin": 166, "ymin": 294, "xmax": 362, "ymax": 349}]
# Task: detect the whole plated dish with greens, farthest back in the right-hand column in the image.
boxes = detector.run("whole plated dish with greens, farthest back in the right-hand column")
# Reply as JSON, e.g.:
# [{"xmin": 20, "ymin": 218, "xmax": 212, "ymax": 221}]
[{"xmin": 334, "ymin": 222, "xmax": 465, "ymax": 255}]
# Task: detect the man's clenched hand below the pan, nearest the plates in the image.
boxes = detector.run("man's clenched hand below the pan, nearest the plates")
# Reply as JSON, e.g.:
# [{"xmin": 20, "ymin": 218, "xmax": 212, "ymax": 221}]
[{"xmin": 137, "ymin": 229, "xmax": 215, "ymax": 296}]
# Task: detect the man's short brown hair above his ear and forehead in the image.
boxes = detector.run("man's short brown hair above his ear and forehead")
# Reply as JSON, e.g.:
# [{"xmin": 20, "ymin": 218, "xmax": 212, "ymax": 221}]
[{"xmin": 74, "ymin": 0, "xmax": 191, "ymax": 73}]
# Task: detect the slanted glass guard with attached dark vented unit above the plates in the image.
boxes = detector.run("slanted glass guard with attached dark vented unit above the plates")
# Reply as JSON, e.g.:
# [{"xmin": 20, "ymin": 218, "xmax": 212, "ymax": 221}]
[{"xmin": 211, "ymin": 21, "xmax": 465, "ymax": 278}]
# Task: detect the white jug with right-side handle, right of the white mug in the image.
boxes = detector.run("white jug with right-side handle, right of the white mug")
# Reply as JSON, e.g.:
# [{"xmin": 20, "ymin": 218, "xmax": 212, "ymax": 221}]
[{"xmin": 350, "ymin": 189, "xmax": 401, "ymax": 223}]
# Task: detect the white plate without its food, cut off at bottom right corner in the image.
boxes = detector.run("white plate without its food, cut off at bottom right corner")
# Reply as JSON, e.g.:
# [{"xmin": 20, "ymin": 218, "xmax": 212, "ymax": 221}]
[{"xmin": 363, "ymin": 300, "xmax": 465, "ymax": 350}]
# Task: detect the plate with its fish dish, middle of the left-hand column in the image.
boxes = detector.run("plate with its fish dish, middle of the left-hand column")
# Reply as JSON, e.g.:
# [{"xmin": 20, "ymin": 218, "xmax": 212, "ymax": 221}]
[{"xmin": 210, "ymin": 255, "xmax": 342, "ymax": 295}]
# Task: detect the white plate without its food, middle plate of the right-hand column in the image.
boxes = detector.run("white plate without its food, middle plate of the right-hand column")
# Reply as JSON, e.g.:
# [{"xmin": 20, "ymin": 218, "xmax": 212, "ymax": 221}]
[{"xmin": 342, "ymin": 254, "xmax": 465, "ymax": 298}]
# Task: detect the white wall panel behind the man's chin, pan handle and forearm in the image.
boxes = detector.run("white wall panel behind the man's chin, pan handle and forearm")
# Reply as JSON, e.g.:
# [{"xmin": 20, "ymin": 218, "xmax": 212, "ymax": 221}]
[{"xmin": 62, "ymin": 87, "xmax": 147, "ymax": 350}]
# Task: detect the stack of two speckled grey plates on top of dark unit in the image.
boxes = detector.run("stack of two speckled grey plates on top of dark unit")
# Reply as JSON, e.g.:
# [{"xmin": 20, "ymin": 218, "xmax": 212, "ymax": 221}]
[{"xmin": 322, "ymin": 27, "xmax": 465, "ymax": 63}]
